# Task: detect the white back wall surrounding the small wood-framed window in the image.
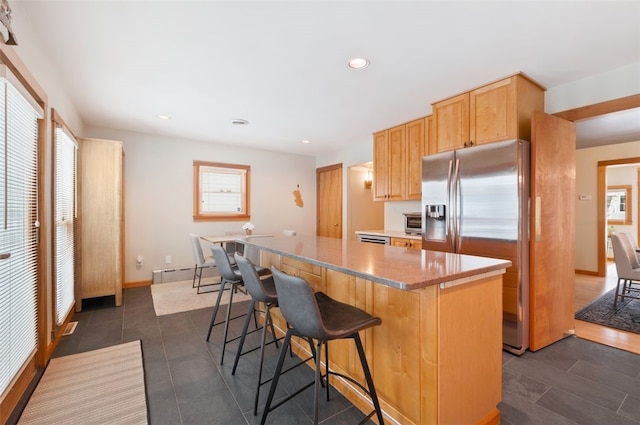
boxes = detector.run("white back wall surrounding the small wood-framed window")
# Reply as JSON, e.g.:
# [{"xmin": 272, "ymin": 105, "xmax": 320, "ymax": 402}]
[{"xmin": 84, "ymin": 127, "xmax": 316, "ymax": 282}]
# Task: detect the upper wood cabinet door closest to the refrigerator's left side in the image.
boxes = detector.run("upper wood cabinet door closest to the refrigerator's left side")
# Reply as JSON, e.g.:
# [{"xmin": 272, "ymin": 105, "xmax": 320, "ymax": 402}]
[{"xmin": 406, "ymin": 118, "xmax": 428, "ymax": 200}]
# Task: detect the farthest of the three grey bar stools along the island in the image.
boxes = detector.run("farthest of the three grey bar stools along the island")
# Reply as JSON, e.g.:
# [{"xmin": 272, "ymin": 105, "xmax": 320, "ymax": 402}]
[{"xmin": 207, "ymin": 244, "xmax": 271, "ymax": 364}]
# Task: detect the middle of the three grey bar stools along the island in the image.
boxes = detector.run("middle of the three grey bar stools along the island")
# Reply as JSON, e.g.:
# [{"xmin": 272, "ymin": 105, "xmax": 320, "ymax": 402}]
[{"xmin": 231, "ymin": 253, "xmax": 278, "ymax": 416}]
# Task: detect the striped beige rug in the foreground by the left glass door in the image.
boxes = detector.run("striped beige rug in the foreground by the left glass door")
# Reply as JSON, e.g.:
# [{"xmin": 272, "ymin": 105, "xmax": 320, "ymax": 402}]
[{"xmin": 18, "ymin": 341, "xmax": 147, "ymax": 425}]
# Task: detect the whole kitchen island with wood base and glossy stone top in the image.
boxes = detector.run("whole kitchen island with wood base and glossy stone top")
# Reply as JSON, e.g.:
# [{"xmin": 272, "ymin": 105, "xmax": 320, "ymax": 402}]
[{"xmin": 238, "ymin": 236, "xmax": 510, "ymax": 424}]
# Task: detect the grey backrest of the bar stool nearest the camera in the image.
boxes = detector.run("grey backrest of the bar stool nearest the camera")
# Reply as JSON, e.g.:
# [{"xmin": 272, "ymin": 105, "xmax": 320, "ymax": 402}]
[{"xmin": 271, "ymin": 266, "xmax": 327, "ymax": 341}]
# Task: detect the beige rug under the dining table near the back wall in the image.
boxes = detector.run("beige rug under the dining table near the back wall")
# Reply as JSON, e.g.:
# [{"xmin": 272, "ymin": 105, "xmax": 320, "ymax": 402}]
[{"xmin": 151, "ymin": 280, "xmax": 251, "ymax": 316}]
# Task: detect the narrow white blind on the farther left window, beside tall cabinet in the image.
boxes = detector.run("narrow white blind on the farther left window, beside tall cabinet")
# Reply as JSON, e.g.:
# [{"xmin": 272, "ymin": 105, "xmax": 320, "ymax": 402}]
[{"xmin": 54, "ymin": 123, "xmax": 78, "ymax": 326}]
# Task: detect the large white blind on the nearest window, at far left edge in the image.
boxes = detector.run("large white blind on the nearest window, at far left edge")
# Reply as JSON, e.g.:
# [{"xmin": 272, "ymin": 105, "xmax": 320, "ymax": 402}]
[{"xmin": 0, "ymin": 67, "xmax": 42, "ymax": 395}]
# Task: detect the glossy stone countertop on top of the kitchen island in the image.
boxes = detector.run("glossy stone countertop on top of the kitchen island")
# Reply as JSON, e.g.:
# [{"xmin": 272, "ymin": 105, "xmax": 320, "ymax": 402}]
[{"xmin": 237, "ymin": 236, "xmax": 511, "ymax": 290}]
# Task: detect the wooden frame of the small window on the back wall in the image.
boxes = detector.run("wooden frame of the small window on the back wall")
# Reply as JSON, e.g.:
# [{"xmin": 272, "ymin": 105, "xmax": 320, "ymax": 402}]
[{"xmin": 193, "ymin": 160, "xmax": 251, "ymax": 221}]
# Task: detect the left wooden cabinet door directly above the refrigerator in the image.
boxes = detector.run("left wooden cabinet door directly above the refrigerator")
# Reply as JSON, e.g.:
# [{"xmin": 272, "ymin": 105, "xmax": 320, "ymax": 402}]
[{"xmin": 433, "ymin": 93, "xmax": 469, "ymax": 152}]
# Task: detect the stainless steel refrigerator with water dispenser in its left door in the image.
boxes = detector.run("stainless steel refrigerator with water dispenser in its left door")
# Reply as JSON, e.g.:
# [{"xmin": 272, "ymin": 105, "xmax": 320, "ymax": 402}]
[{"xmin": 422, "ymin": 140, "xmax": 530, "ymax": 354}]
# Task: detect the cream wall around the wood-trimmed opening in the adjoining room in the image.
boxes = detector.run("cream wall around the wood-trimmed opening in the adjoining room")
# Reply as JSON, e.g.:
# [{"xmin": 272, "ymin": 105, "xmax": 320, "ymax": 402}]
[{"xmin": 576, "ymin": 141, "xmax": 640, "ymax": 272}]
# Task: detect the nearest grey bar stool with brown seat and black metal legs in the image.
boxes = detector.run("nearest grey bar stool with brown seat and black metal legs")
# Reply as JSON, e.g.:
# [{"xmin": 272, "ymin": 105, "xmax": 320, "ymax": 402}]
[{"xmin": 260, "ymin": 267, "xmax": 384, "ymax": 425}]
